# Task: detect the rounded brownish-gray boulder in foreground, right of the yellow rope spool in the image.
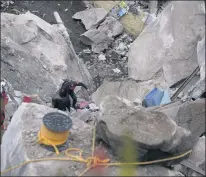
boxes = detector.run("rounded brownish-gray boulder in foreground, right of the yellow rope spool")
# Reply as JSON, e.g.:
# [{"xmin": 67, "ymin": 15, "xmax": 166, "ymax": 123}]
[{"xmin": 97, "ymin": 96, "xmax": 197, "ymax": 159}]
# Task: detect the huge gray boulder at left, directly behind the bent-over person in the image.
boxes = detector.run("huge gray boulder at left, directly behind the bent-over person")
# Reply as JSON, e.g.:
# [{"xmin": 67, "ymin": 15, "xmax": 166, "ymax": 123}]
[{"xmin": 1, "ymin": 12, "xmax": 92, "ymax": 101}]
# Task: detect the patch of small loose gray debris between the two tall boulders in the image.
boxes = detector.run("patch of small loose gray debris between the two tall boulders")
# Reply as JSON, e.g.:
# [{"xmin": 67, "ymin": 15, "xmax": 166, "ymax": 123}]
[{"xmin": 78, "ymin": 33, "xmax": 133, "ymax": 89}]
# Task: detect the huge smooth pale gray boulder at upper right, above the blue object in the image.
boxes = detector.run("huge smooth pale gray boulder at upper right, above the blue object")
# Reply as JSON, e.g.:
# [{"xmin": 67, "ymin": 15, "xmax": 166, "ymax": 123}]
[{"xmin": 128, "ymin": 1, "xmax": 205, "ymax": 86}]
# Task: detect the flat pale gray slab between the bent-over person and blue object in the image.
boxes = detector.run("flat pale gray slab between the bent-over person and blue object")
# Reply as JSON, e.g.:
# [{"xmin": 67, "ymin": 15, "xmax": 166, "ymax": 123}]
[{"xmin": 92, "ymin": 79, "xmax": 155, "ymax": 105}]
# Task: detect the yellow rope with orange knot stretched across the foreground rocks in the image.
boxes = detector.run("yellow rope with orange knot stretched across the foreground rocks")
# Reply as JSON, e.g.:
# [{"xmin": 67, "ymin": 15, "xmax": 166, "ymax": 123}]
[{"xmin": 1, "ymin": 126, "xmax": 192, "ymax": 176}]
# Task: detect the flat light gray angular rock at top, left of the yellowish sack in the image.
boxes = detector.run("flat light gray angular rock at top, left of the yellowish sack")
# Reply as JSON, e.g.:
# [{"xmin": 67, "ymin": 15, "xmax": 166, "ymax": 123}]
[{"xmin": 72, "ymin": 8, "xmax": 108, "ymax": 30}]
